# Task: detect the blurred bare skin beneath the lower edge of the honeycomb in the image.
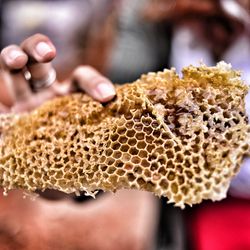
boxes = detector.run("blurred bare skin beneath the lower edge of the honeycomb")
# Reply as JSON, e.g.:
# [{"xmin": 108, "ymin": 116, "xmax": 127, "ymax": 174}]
[{"xmin": 0, "ymin": 190, "xmax": 158, "ymax": 250}]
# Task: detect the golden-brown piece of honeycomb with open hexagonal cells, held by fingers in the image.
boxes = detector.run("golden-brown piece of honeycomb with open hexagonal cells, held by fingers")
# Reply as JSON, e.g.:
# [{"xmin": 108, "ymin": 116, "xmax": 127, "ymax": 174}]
[{"xmin": 0, "ymin": 62, "xmax": 250, "ymax": 208}]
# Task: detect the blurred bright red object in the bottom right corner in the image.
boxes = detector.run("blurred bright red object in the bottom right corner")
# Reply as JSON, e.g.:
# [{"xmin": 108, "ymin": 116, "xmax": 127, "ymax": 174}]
[{"xmin": 188, "ymin": 198, "xmax": 250, "ymax": 250}]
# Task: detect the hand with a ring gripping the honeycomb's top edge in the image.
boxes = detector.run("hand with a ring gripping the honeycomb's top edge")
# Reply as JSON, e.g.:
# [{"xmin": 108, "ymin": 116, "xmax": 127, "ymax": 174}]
[{"xmin": 0, "ymin": 34, "xmax": 115, "ymax": 113}]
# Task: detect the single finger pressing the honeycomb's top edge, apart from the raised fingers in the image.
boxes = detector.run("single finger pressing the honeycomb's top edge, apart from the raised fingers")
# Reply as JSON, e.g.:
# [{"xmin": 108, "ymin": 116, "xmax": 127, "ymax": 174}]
[{"xmin": 73, "ymin": 66, "xmax": 116, "ymax": 102}]
